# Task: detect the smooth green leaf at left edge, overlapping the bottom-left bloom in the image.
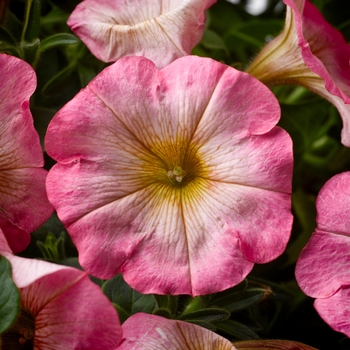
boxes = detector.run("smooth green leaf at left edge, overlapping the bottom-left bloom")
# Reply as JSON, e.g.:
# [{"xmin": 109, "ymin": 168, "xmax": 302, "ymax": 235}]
[{"xmin": 0, "ymin": 255, "xmax": 20, "ymax": 333}]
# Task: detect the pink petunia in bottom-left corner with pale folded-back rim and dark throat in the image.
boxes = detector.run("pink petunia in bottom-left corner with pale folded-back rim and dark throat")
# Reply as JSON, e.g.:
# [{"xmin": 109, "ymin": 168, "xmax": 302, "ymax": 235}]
[{"xmin": 0, "ymin": 231, "xmax": 122, "ymax": 350}]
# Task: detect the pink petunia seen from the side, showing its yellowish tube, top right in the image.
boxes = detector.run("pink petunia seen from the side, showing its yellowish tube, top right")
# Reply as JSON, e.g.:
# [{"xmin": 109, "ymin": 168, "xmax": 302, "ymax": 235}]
[{"xmin": 247, "ymin": 0, "xmax": 350, "ymax": 146}]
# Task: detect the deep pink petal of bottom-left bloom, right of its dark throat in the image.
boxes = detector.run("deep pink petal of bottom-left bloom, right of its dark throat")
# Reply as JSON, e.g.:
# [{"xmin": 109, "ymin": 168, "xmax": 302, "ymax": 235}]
[{"xmin": 21, "ymin": 268, "xmax": 122, "ymax": 350}]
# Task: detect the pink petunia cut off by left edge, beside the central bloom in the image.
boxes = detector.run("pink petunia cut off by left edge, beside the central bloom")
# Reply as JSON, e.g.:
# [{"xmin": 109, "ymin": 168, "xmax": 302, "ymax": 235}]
[{"xmin": 0, "ymin": 54, "xmax": 53, "ymax": 252}]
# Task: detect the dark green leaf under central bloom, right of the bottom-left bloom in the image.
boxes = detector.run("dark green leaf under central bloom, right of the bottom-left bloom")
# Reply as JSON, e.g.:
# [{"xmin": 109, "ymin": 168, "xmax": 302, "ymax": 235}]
[{"xmin": 102, "ymin": 274, "xmax": 156, "ymax": 322}]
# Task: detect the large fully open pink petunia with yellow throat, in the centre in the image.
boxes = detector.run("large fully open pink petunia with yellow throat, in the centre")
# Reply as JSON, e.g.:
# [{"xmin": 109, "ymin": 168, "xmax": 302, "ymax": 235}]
[{"xmin": 45, "ymin": 56, "xmax": 293, "ymax": 295}]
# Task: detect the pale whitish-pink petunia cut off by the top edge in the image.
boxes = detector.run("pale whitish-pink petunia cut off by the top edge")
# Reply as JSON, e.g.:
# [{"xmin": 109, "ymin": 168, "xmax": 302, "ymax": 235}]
[{"xmin": 67, "ymin": 0, "xmax": 216, "ymax": 68}]
